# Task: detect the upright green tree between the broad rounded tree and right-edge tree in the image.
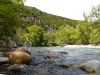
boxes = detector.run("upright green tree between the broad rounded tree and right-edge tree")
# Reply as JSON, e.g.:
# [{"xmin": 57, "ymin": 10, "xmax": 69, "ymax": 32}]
[{"xmin": 76, "ymin": 22, "xmax": 91, "ymax": 44}]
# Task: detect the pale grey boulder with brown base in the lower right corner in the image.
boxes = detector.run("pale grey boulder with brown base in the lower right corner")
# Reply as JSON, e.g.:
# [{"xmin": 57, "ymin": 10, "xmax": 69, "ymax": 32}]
[{"xmin": 78, "ymin": 60, "xmax": 100, "ymax": 75}]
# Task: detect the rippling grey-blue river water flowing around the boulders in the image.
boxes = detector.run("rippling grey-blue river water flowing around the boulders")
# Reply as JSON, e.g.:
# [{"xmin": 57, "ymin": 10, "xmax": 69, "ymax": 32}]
[{"xmin": 1, "ymin": 46, "xmax": 100, "ymax": 75}]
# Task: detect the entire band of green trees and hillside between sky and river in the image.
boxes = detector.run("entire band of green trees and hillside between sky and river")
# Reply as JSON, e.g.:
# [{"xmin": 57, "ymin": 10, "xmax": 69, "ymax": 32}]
[{"xmin": 0, "ymin": 0, "xmax": 100, "ymax": 46}]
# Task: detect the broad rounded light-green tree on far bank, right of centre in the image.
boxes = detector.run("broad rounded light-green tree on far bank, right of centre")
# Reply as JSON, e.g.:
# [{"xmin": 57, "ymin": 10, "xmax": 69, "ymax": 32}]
[{"xmin": 55, "ymin": 25, "xmax": 77, "ymax": 46}]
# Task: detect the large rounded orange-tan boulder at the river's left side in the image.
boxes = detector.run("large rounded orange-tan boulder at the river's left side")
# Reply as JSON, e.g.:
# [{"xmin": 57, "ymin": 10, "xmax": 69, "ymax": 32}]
[{"xmin": 9, "ymin": 48, "xmax": 32, "ymax": 64}]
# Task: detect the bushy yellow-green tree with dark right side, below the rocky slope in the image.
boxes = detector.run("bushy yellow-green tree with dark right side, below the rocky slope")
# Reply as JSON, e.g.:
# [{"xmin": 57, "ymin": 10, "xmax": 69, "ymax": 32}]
[{"xmin": 17, "ymin": 25, "xmax": 44, "ymax": 46}]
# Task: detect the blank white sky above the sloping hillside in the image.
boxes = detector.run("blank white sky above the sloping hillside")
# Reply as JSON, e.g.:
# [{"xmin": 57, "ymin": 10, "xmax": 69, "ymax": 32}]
[{"xmin": 25, "ymin": 0, "xmax": 100, "ymax": 20}]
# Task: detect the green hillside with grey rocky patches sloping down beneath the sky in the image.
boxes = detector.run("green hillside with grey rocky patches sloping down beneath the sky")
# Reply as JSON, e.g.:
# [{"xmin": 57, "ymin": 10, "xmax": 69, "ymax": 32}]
[{"xmin": 19, "ymin": 6, "xmax": 78, "ymax": 29}]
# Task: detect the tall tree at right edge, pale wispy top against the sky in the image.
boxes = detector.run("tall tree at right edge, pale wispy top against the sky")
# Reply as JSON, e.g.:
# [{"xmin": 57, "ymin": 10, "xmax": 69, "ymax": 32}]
[{"xmin": 86, "ymin": 5, "xmax": 100, "ymax": 44}]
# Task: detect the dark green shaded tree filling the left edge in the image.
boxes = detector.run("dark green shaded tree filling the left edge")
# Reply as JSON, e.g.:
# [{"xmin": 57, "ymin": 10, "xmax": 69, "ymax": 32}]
[{"xmin": 0, "ymin": 0, "xmax": 25, "ymax": 46}]
